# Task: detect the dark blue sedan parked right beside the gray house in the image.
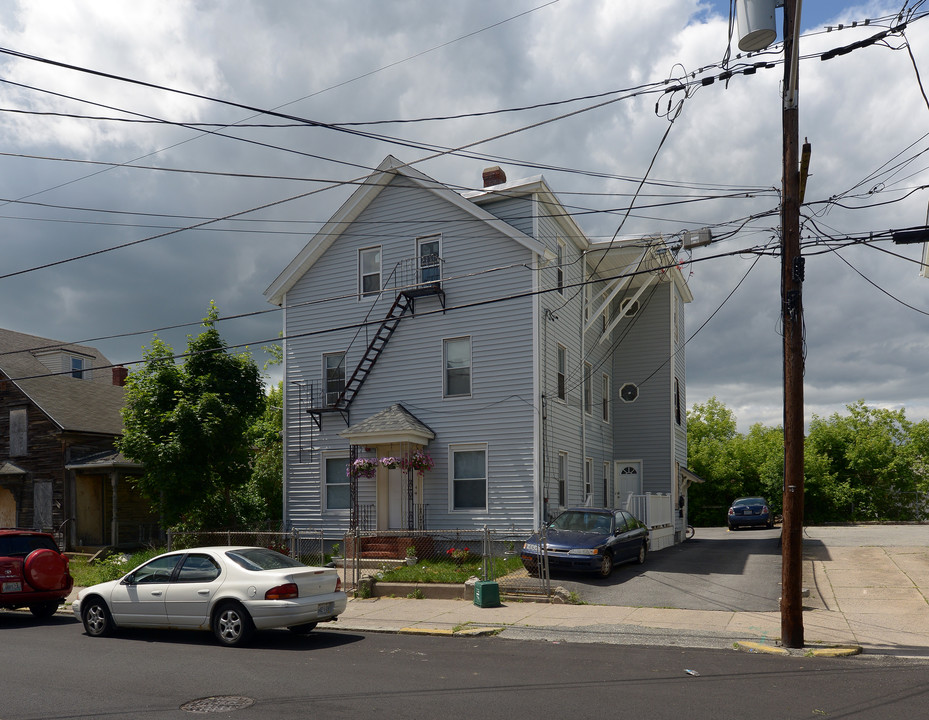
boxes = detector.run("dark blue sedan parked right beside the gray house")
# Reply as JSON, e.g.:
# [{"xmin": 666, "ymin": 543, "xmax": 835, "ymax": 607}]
[{"xmin": 520, "ymin": 507, "xmax": 648, "ymax": 577}]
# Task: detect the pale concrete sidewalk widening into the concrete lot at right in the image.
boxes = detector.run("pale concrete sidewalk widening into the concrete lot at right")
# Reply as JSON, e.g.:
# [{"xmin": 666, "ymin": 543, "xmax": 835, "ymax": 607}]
[{"xmin": 321, "ymin": 547, "xmax": 929, "ymax": 658}]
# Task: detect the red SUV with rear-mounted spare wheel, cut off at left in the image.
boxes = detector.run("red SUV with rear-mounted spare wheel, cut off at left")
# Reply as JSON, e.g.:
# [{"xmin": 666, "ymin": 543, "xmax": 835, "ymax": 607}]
[{"xmin": 0, "ymin": 530, "xmax": 74, "ymax": 619}]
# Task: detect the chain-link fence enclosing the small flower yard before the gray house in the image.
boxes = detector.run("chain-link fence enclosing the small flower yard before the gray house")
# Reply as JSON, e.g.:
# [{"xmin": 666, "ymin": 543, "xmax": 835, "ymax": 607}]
[{"xmin": 334, "ymin": 529, "xmax": 551, "ymax": 599}]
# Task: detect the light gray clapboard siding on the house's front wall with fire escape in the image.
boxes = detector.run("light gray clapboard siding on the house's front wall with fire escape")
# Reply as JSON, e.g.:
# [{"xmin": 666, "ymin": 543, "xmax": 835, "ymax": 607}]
[{"xmin": 285, "ymin": 179, "xmax": 534, "ymax": 533}]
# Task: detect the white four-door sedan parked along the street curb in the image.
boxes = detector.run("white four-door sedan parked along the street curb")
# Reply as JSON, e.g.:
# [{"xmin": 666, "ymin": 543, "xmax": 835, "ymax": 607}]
[{"xmin": 72, "ymin": 547, "xmax": 347, "ymax": 646}]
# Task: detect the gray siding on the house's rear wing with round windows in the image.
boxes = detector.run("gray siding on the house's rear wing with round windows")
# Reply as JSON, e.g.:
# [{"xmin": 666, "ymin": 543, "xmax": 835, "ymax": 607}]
[{"xmin": 613, "ymin": 283, "xmax": 674, "ymax": 493}]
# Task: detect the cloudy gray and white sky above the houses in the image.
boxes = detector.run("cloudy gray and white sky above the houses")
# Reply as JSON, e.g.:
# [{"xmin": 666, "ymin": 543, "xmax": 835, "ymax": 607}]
[{"xmin": 0, "ymin": 0, "xmax": 929, "ymax": 431}]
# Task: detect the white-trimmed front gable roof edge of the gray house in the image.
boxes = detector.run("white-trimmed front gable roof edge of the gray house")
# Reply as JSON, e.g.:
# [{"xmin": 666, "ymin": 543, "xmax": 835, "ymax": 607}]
[{"xmin": 264, "ymin": 155, "xmax": 544, "ymax": 305}]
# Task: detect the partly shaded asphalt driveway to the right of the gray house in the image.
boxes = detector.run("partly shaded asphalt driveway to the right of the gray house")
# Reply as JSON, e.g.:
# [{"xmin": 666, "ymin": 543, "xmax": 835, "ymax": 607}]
[{"xmin": 552, "ymin": 528, "xmax": 781, "ymax": 612}]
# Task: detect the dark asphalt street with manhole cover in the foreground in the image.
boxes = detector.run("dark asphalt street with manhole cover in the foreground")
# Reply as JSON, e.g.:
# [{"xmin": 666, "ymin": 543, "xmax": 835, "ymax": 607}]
[{"xmin": 0, "ymin": 612, "xmax": 929, "ymax": 720}]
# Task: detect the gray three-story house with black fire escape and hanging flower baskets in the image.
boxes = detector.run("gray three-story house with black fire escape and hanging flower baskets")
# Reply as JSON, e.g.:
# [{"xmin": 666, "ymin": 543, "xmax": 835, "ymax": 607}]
[{"xmin": 265, "ymin": 156, "xmax": 692, "ymax": 549}]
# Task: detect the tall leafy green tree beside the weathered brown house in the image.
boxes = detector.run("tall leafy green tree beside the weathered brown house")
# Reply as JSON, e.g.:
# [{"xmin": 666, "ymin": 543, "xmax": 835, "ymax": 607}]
[{"xmin": 119, "ymin": 303, "xmax": 263, "ymax": 527}]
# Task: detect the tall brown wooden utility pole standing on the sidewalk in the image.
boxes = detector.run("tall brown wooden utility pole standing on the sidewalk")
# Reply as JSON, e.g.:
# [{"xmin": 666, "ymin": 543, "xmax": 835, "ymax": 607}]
[{"xmin": 781, "ymin": 0, "xmax": 804, "ymax": 648}]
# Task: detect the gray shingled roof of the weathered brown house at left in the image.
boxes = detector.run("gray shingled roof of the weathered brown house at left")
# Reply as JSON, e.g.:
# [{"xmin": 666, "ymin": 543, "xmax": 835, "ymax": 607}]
[{"xmin": 0, "ymin": 329, "xmax": 125, "ymax": 435}]
